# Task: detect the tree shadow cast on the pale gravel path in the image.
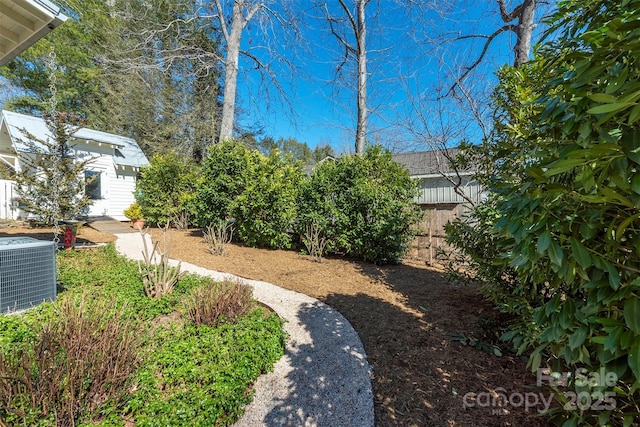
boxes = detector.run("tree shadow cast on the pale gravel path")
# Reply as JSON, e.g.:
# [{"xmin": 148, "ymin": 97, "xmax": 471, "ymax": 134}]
[{"xmin": 263, "ymin": 302, "xmax": 374, "ymax": 426}]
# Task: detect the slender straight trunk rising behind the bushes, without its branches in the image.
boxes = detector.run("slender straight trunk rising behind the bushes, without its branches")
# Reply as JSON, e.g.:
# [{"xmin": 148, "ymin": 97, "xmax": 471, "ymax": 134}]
[{"xmin": 356, "ymin": 0, "xmax": 368, "ymax": 155}]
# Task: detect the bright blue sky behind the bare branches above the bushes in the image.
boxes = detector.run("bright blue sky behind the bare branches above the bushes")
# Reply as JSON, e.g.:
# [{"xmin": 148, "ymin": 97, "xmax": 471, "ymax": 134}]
[{"xmin": 0, "ymin": 0, "xmax": 540, "ymax": 152}]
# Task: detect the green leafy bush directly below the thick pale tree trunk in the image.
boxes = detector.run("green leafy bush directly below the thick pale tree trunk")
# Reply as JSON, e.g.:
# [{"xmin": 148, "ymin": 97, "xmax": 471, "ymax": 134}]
[{"xmin": 190, "ymin": 141, "xmax": 260, "ymax": 227}]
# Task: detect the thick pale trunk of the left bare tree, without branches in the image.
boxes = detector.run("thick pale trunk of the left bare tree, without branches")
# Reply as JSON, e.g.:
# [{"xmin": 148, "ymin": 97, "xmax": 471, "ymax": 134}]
[{"xmin": 218, "ymin": 1, "xmax": 245, "ymax": 142}]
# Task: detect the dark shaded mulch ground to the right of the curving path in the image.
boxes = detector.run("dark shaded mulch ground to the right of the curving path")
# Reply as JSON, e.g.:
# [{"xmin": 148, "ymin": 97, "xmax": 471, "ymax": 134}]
[{"xmin": 323, "ymin": 264, "xmax": 548, "ymax": 426}]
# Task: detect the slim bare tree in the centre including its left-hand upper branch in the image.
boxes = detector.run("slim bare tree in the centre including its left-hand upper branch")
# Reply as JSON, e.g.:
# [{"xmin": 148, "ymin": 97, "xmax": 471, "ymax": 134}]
[{"xmin": 322, "ymin": 0, "xmax": 370, "ymax": 154}]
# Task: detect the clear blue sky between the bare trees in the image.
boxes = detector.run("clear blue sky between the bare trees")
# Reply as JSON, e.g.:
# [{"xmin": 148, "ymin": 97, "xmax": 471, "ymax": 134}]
[{"xmin": 232, "ymin": 0, "xmax": 536, "ymax": 151}]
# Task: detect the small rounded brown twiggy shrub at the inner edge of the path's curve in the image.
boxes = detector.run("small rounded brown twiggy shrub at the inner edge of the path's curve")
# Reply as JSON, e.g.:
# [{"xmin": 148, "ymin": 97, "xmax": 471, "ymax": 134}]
[{"xmin": 187, "ymin": 282, "xmax": 253, "ymax": 326}]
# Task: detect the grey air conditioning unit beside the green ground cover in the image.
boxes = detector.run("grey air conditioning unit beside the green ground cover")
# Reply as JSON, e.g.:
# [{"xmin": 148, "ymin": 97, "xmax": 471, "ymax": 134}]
[{"xmin": 0, "ymin": 237, "xmax": 56, "ymax": 314}]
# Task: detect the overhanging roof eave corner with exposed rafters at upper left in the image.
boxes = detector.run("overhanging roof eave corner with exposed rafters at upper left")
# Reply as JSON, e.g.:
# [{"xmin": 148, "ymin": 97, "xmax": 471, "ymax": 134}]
[{"xmin": 0, "ymin": 0, "xmax": 67, "ymax": 65}]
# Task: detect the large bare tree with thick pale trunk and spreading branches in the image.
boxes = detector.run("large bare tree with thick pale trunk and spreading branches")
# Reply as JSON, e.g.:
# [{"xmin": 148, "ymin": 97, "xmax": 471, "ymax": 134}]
[{"xmin": 103, "ymin": 0, "xmax": 297, "ymax": 147}]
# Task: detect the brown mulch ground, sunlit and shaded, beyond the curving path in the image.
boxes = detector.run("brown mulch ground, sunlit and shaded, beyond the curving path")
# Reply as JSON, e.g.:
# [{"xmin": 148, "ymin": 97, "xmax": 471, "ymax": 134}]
[{"xmin": 0, "ymin": 227, "xmax": 548, "ymax": 426}]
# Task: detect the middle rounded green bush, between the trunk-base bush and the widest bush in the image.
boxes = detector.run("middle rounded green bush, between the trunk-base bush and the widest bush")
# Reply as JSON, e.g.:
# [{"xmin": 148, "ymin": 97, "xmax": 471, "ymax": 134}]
[{"xmin": 230, "ymin": 151, "xmax": 302, "ymax": 249}]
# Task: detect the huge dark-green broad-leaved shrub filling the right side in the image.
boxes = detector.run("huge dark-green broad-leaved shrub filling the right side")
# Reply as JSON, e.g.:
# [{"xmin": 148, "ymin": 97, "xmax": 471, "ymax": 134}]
[{"xmin": 448, "ymin": 0, "xmax": 640, "ymax": 426}]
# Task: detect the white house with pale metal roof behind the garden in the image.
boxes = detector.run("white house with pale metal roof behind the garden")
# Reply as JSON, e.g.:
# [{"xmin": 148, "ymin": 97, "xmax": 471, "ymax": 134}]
[{"xmin": 0, "ymin": 111, "xmax": 149, "ymax": 221}]
